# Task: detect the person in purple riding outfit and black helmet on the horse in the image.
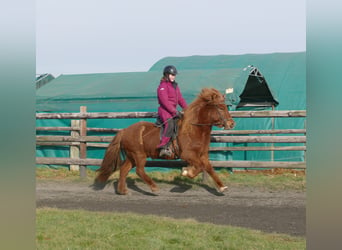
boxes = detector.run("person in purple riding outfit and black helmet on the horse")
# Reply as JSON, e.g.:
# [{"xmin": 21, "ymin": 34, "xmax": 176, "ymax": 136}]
[{"xmin": 157, "ymin": 65, "xmax": 187, "ymax": 156}]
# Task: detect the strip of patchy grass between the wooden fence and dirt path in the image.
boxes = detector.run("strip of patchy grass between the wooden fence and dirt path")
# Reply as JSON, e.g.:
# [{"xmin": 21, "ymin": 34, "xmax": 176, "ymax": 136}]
[{"xmin": 36, "ymin": 168, "xmax": 306, "ymax": 191}]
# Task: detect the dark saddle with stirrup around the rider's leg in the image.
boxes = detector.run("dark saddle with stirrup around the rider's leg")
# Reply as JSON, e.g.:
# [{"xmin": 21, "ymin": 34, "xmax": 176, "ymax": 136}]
[{"xmin": 155, "ymin": 116, "xmax": 180, "ymax": 160}]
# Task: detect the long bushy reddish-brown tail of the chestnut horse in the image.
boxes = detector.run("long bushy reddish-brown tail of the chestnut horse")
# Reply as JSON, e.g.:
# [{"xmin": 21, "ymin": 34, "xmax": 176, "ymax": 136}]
[{"xmin": 96, "ymin": 131, "xmax": 123, "ymax": 182}]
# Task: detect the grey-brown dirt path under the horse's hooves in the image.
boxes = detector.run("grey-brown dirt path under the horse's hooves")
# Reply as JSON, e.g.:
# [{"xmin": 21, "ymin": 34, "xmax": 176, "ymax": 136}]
[{"xmin": 36, "ymin": 180, "xmax": 305, "ymax": 236}]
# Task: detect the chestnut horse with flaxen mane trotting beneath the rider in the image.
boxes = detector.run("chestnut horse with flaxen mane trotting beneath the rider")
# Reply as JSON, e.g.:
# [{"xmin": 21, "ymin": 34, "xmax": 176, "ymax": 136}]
[{"xmin": 95, "ymin": 88, "xmax": 235, "ymax": 194}]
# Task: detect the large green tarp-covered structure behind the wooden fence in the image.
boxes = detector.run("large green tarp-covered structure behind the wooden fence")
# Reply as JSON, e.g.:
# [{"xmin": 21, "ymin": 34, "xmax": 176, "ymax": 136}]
[{"xmin": 36, "ymin": 52, "xmax": 306, "ymax": 167}]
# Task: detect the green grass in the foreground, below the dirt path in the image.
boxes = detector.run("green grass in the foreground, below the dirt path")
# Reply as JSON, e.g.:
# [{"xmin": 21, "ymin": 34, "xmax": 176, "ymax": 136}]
[{"xmin": 36, "ymin": 208, "xmax": 306, "ymax": 250}]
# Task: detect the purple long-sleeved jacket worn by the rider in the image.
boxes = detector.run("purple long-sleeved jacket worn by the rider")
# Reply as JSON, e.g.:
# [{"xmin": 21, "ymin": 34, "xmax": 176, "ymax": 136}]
[{"xmin": 157, "ymin": 81, "xmax": 188, "ymax": 121}]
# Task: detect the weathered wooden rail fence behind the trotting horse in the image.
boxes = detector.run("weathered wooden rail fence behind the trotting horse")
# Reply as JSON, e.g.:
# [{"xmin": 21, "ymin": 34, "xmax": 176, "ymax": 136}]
[{"xmin": 36, "ymin": 106, "xmax": 306, "ymax": 176}]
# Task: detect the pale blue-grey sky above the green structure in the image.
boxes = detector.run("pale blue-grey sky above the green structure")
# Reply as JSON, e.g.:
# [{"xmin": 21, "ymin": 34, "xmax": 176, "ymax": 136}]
[{"xmin": 36, "ymin": 0, "xmax": 306, "ymax": 76}]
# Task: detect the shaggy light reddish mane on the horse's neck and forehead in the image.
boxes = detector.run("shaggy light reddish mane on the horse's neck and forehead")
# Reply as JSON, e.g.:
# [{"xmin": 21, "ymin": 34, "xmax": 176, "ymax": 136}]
[{"xmin": 182, "ymin": 88, "xmax": 224, "ymax": 131}]
